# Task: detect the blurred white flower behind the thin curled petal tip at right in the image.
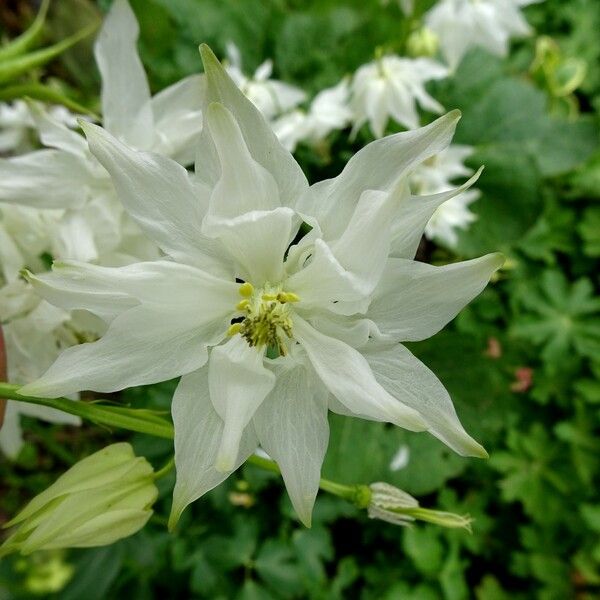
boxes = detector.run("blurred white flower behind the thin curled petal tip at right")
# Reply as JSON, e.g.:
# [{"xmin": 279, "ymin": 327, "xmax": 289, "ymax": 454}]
[{"xmin": 410, "ymin": 145, "xmax": 480, "ymax": 248}]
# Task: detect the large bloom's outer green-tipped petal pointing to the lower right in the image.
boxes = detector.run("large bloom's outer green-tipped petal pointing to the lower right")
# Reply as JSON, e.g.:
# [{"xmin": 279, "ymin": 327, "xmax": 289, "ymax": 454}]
[{"xmin": 364, "ymin": 344, "xmax": 487, "ymax": 458}]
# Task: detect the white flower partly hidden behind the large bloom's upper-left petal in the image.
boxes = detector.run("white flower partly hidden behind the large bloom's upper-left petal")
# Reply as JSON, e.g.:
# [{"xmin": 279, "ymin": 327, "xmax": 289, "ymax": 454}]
[{"xmin": 0, "ymin": 0, "xmax": 204, "ymax": 264}]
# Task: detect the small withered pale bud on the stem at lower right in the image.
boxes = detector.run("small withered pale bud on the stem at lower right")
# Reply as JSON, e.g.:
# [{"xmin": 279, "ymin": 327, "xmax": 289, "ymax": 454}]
[{"xmin": 367, "ymin": 482, "xmax": 471, "ymax": 531}]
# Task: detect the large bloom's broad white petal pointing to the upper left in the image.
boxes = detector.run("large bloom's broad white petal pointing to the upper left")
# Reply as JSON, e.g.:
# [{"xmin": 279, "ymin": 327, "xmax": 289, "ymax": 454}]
[{"xmin": 83, "ymin": 124, "xmax": 228, "ymax": 274}]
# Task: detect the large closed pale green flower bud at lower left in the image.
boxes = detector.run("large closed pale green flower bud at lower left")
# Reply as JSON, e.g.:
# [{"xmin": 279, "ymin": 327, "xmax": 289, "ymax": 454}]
[{"xmin": 0, "ymin": 443, "xmax": 158, "ymax": 556}]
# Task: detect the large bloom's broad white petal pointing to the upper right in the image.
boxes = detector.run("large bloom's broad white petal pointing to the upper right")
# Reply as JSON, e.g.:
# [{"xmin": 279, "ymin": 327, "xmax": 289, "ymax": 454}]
[{"xmin": 297, "ymin": 111, "xmax": 460, "ymax": 240}]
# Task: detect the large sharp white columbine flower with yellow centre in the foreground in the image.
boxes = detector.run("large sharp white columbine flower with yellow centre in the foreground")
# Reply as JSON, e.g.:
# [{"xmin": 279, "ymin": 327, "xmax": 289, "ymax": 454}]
[{"xmin": 22, "ymin": 47, "xmax": 503, "ymax": 525}]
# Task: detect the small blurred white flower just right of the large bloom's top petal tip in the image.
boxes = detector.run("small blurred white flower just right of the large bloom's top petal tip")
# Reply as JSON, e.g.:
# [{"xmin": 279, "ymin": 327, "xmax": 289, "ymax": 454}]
[{"xmin": 226, "ymin": 42, "xmax": 306, "ymax": 120}]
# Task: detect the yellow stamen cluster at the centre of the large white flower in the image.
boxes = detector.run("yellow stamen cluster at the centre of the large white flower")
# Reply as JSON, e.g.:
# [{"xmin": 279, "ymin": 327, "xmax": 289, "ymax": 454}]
[{"xmin": 227, "ymin": 282, "xmax": 300, "ymax": 356}]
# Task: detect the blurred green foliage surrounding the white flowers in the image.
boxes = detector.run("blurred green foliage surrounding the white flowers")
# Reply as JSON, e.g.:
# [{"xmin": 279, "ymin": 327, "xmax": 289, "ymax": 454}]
[{"xmin": 0, "ymin": 0, "xmax": 600, "ymax": 600}]
